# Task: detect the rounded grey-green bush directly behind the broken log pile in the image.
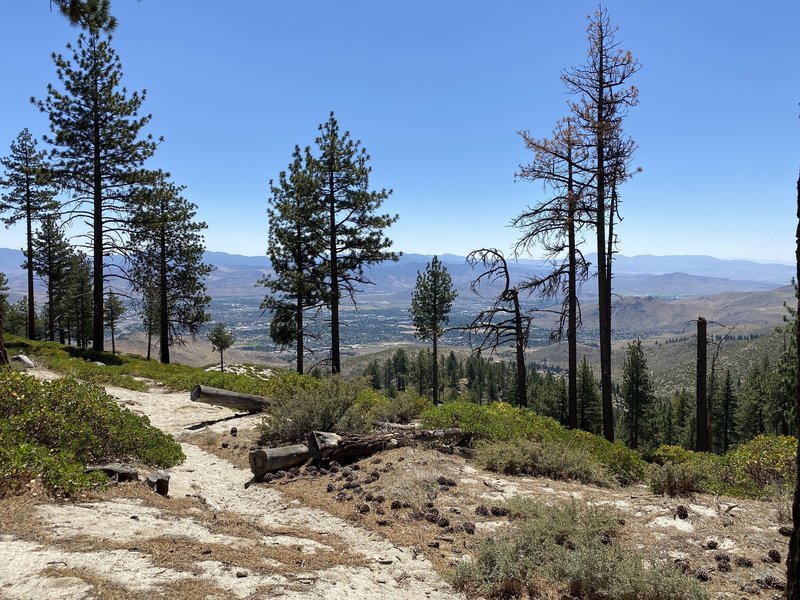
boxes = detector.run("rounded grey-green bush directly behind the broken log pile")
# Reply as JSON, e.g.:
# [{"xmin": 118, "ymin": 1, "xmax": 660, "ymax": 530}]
[{"xmin": 261, "ymin": 374, "xmax": 390, "ymax": 443}]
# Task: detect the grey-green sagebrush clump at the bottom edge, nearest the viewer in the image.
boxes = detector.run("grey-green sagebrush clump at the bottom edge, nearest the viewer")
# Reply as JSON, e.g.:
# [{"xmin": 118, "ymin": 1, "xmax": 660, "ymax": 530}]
[{"xmin": 453, "ymin": 499, "xmax": 708, "ymax": 600}]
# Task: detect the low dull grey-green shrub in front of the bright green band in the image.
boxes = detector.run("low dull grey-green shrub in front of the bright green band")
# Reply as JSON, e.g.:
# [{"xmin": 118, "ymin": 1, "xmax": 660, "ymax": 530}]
[{"xmin": 477, "ymin": 440, "xmax": 614, "ymax": 487}]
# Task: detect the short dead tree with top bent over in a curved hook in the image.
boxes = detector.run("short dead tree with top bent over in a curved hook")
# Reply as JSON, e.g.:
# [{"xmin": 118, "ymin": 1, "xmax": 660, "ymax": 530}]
[{"xmin": 465, "ymin": 248, "xmax": 531, "ymax": 406}]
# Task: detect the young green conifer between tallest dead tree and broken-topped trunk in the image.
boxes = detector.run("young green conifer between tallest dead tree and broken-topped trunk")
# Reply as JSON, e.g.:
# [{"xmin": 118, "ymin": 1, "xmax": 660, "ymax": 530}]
[{"xmin": 621, "ymin": 339, "xmax": 654, "ymax": 449}]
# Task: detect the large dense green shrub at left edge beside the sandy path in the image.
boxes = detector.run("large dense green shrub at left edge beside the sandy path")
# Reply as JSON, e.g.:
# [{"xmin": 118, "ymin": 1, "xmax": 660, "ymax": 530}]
[{"xmin": 0, "ymin": 369, "xmax": 185, "ymax": 493}]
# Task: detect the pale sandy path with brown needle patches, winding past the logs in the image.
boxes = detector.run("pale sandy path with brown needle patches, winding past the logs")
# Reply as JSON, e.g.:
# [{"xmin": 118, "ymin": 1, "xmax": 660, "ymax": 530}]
[{"xmin": 0, "ymin": 371, "xmax": 458, "ymax": 600}]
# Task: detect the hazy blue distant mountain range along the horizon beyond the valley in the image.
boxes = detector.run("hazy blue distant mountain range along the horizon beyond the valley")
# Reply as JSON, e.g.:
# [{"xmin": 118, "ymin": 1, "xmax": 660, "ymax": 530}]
[{"xmin": 0, "ymin": 248, "xmax": 795, "ymax": 304}]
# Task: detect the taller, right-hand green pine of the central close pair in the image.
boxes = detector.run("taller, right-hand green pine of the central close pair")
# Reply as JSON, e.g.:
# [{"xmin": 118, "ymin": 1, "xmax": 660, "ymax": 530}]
[{"xmin": 313, "ymin": 113, "xmax": 399, "ymax": 374}]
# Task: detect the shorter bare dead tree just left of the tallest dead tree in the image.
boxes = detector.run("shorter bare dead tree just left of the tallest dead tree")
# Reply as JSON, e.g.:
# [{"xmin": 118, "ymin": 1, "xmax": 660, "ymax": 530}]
[{"xmin": 511, "ymin": 118, "xmax": 592, "ymax": 429}]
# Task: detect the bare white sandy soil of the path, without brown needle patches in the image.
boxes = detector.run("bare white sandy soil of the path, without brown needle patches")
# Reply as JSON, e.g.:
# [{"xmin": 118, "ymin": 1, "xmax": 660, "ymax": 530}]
[{"xmin": 0, "ymin": 376, "xmax": 459, "ymax": 600}]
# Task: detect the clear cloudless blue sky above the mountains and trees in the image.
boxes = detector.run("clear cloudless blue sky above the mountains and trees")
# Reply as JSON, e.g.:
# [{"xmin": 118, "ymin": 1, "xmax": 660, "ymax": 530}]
[{"xmin": 0, "ymin": 0, "xmax": 800, "ymax": 261}]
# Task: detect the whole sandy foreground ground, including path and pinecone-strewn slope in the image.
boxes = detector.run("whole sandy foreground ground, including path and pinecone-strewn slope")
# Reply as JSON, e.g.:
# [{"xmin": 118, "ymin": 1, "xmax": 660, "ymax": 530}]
[{"xmin": 0, "ymin": 371, "xmax": 788, "ymax": 600}]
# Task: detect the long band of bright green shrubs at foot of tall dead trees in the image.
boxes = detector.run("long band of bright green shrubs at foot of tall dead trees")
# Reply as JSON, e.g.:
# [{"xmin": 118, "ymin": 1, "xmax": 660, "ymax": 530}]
[{"xmin": 422, "ymin": 401, "xmax": 647, "ymax": 485}]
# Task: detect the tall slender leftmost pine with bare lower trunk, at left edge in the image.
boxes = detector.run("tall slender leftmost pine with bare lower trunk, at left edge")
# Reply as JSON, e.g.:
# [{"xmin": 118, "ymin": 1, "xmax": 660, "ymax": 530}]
[{"xmin": 0, "ymin": 129, "xmax": 57, "ymax": 339}]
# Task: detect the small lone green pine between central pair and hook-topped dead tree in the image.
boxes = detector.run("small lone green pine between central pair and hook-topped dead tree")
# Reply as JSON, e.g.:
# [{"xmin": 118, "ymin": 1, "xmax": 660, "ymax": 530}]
[{"xmin": 409, "ymin": 256, "xmax": 458, "ymax": 404}]
